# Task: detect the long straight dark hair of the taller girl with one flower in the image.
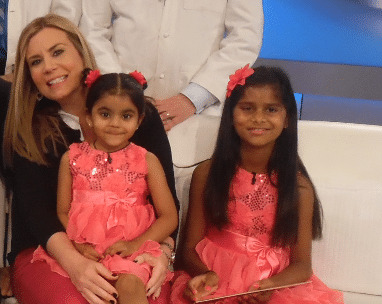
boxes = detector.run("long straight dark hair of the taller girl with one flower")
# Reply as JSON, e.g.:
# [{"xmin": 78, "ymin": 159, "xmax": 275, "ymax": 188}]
[{"xmin": 204, "ymin": 66, "xmax": 322, "ymax": 246}]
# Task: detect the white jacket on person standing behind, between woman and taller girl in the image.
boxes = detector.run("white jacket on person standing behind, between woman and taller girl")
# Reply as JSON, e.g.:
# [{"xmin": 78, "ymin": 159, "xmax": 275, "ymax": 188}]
[{"xmin": 80, "ymin": 0, "xmax": 263, "ymax": 109}]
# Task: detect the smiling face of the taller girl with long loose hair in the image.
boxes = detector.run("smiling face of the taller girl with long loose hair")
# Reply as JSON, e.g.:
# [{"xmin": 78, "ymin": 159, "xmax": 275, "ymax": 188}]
[{"xmin": 233, "ymin": 85, "xmax": 288, "ymax": 151}]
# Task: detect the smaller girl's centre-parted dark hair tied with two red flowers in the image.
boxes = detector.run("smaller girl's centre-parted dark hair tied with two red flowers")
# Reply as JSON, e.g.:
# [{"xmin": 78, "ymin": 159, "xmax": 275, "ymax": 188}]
[{"xmin": 83, "ymin": 69, "xmax": 148, "ymax": 115}]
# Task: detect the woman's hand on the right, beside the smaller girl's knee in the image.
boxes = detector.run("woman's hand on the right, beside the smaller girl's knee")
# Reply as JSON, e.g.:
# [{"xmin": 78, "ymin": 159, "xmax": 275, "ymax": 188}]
[{"xmin": 135, "ymin": 253, "xmax": 168, "ymax": 299}]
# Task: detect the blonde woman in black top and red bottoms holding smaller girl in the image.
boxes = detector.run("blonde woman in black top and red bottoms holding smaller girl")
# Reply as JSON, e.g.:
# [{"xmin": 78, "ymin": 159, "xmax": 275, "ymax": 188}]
[{"xmin": 3, "ymin": 15, "xmax": 175, "ymax": 304}]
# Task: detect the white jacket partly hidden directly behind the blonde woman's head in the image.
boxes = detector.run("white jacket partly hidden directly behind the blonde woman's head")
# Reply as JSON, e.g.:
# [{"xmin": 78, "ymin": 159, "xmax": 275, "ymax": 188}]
[{"xmin": 5, "ymin": 0, "xmax": 81, "ymax": 74}]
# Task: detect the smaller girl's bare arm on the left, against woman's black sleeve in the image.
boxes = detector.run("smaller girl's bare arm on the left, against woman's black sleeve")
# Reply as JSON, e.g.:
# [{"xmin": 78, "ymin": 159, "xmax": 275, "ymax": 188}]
[{"xmin": 57, "ymin": 152, "xmax": 72, "ymax": 229}]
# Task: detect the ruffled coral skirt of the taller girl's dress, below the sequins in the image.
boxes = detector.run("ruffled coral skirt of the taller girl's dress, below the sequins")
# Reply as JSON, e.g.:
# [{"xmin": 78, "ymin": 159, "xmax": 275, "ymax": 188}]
[{"xmin": 171, "ymin": 229, "xmax": 344, "ymax": 304}]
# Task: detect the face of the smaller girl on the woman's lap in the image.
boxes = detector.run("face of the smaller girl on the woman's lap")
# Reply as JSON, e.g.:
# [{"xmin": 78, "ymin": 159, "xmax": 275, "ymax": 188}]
[{"xmin": 86, "ymin": 94, "xmax": 143, "ymax": 152}]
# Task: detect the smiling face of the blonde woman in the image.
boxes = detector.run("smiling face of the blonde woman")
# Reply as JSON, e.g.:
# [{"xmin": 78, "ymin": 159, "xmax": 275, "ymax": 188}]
[{"xmin": 26, "ymin": 27, "xmax": 85, "ymax": 110}]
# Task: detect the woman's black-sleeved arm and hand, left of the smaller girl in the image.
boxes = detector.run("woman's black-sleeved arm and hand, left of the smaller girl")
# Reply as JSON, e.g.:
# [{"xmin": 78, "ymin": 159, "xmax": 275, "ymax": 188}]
[{"xmin": 12, "ymin": 155, "xmax": 116, "ymax": 304}]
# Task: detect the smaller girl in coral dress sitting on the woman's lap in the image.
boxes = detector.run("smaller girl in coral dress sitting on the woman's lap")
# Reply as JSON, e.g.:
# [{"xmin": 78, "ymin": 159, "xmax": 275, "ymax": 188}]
[{"xmin": 33, "ymin": 71, "xmax": 177, "ymax": 304}]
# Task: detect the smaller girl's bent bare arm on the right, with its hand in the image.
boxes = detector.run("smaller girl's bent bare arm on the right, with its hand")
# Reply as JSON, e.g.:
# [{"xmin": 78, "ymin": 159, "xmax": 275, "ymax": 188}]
[{"xmin": 105, "ymin": 152, "xmax": 178, "ymax": 257}]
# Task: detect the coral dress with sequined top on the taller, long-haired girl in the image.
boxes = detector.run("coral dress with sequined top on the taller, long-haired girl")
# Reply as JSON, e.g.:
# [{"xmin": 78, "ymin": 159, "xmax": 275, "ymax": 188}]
[{"xmin": 171, "ymin": 168, "xmax": 343, "ymax": 304}]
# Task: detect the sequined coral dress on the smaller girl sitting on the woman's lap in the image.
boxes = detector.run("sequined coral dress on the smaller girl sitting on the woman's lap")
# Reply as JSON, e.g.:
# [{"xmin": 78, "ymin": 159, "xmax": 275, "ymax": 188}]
[{"xmin": 32, "ymin": 142, "xmax": 172, "ymax": 284}]
